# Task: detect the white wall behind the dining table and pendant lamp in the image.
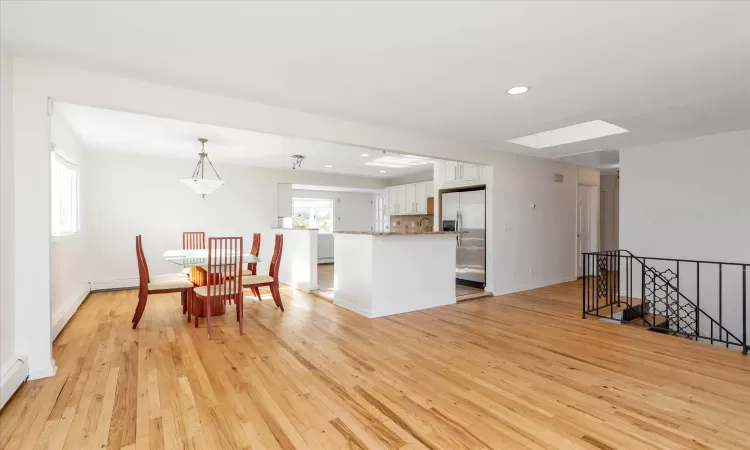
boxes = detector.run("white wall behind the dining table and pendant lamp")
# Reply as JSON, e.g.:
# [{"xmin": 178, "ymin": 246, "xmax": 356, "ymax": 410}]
[{"xmin": 82, "ymin": 150, "xmax": 384, "ymax": 289}]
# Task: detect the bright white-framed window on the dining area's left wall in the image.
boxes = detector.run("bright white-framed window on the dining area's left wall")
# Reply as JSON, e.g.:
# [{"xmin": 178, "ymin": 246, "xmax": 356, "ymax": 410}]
[{"xmin": 51, "ymin": 152, "xmax": 78, "ymax": 236}]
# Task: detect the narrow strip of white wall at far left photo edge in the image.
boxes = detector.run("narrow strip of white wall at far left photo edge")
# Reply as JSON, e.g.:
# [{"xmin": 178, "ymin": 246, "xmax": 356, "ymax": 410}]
[{"xmin": 0, "ymin": 52, "xmax": 17, "ymax": 390}]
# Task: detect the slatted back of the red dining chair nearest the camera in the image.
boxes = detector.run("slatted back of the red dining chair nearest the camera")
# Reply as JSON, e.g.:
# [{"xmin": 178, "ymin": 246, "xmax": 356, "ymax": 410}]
[{"xmin": 207, "ymin": 237, "xmax": 244, "ymax": 309}]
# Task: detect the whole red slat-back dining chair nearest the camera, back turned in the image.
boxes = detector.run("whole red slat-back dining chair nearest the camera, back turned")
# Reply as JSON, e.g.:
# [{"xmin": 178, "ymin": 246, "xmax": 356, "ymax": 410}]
[{"xmin": 188, "ymin": 237, "xmax": 245, "ymax": 339}]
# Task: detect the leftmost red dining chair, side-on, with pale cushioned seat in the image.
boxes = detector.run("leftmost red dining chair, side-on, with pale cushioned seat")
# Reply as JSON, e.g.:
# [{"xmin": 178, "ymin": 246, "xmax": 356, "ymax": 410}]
[{"xmin": 133, "ymin": 235, "xmax": 193, "ymax": 329}]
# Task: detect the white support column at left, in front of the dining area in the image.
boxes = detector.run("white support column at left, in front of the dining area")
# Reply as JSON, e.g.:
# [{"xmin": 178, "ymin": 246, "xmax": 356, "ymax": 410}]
[{"xmin": 13, "ymin": 60, "xmax": 56, "ymax": 379}]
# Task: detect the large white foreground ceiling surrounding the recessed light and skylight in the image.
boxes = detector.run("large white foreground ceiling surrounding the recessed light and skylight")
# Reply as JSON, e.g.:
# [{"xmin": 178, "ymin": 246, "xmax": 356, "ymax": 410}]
[{"xmin": 0, "ymin": 1, "xmax": 750, "ymax": 157}]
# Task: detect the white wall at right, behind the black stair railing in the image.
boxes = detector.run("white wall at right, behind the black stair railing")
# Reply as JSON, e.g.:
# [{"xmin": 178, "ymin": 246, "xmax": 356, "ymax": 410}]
[{"xmin": 620, "ymin": 130, "xmax": 750, "ymax": 348}]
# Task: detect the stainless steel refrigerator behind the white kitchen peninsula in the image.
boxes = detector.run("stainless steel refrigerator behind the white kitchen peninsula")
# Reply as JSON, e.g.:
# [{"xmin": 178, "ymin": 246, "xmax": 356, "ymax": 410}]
[{"xmin": 441, "ymin": 188, "xmax": 487, "ymax": 289}]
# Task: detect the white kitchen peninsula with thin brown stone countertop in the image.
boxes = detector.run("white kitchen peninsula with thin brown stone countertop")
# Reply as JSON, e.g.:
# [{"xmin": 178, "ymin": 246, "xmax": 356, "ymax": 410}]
[{"xmin": 333, "ymin": 231, "xmax": 456, "ymax": 318}]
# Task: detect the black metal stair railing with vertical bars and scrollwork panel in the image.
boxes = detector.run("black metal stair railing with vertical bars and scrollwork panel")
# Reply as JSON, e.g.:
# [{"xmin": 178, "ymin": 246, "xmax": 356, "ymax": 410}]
[{"xmin": 582, "ymin": 250, "xmax": 750, "ymax": 354}]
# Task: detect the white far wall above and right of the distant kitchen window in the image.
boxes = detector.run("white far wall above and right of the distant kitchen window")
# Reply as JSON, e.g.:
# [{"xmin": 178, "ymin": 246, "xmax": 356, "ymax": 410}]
[{"xmin": 292, "ymin": 189, "xmax": 374, "ymax": 262}]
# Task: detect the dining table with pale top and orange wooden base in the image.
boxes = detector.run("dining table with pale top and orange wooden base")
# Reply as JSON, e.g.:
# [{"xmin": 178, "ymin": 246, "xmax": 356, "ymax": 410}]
[{"xmin": 164, "ymin": 249, "xmax": 260, "ymax": 317}]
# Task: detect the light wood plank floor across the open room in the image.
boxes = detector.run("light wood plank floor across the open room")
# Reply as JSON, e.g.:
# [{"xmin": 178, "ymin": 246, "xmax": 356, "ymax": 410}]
[{"xmin": 0, "ymin": 282, "xmax": 750, "ymax": 450}]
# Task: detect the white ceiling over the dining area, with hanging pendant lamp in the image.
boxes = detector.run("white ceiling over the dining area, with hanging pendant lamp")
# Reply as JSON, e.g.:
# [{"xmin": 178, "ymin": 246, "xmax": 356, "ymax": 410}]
[{"xmin": 55, "ymin": 103, "xmax": 432, "ymax": 178}]
